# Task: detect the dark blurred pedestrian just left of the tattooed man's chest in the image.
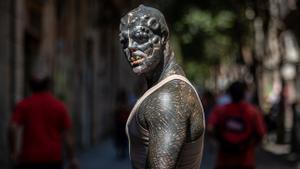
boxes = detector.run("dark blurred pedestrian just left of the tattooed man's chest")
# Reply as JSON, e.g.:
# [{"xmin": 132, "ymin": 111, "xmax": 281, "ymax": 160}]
[{"xmin": 115, "ymin": 90, "xmax": 131, "ymax": 159}]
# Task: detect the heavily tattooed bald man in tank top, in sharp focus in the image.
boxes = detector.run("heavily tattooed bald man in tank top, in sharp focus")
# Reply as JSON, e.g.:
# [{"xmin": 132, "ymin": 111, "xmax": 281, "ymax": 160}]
[{"xmin": 120, "ymin": 5, "xmax": 204, "ymax": 169}]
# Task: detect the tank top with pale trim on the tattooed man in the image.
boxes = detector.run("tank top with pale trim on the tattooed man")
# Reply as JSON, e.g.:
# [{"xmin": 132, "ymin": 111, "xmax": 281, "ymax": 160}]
[{"xmin": 126, "ymin": 75, "xmax": 205, "ymax": 169}]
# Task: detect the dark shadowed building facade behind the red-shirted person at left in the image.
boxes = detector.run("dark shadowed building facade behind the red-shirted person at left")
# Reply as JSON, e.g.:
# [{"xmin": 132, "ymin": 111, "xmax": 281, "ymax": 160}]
[{"xmin": 0, "ymin": 0, "xmax": 148, "ymax": 168}]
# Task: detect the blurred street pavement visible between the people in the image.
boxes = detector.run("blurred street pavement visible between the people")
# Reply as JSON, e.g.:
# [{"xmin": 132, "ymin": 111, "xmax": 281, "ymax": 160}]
[{"xmin": 79, "ymin": 139, "xmax": 300, "ymax": 169}]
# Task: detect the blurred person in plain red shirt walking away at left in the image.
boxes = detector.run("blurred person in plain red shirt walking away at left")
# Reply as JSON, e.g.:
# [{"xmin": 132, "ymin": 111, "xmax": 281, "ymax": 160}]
[{"xmin": 8, "ymin": 77, "xmax": 78, "ymax": 169}]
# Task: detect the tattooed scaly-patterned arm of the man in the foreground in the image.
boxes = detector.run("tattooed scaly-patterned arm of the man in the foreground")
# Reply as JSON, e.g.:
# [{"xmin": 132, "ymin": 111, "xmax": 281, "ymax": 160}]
[{"xmin": 142, "ymin": 82, "xmax": 197, "ymax": 169}]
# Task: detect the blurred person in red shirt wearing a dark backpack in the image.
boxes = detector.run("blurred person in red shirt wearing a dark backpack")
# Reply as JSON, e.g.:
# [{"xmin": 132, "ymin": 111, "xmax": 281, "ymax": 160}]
[{"xmin": 207, "ymin": 81, "xmax": 266, "ymax": 169}]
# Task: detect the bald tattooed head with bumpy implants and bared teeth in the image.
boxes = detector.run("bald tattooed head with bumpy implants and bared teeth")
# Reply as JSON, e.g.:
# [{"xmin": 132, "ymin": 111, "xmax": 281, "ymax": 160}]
[{"xmin": 120, "ymin": 5, "xmax": 169, "ymax": 75}]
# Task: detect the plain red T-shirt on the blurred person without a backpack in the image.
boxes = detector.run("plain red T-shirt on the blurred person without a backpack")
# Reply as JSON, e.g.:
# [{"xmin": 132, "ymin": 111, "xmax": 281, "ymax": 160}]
[{"xmin": 11, "ymin": 92, "xmax": 72, "ymax": 163}]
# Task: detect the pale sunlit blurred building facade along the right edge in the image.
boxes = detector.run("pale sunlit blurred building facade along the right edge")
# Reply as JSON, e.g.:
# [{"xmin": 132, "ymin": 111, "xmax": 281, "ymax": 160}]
[{"xmin": 249, "ymin": 0, "xmax": 300, "ymax": 144}]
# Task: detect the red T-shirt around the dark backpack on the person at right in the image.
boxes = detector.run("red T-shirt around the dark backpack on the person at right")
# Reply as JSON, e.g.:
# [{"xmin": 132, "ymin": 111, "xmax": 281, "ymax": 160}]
[{"xmin": 208, "ymin": 102, "xmax": 266, "ymax": 167}]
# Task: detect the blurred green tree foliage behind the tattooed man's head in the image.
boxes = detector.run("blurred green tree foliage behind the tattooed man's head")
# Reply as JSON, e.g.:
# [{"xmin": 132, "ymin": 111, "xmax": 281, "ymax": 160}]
[{"xmin": 151, "ymin": 0, "xmax": 250, "ymax": 83}]
